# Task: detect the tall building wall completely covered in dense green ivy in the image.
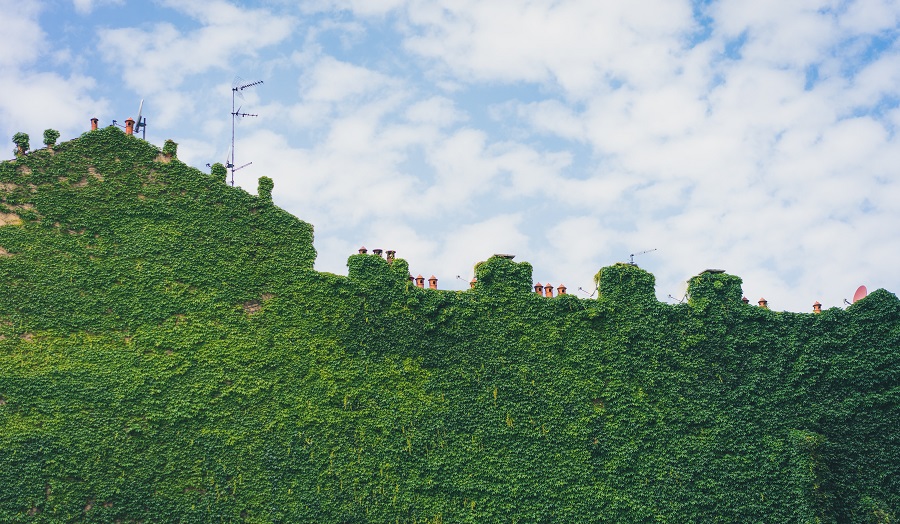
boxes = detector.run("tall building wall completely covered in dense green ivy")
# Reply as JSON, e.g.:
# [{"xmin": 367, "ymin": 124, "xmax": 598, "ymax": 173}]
[{"xmin": 0, "ymin": 128, "xmax": 900, "ymax": 523}]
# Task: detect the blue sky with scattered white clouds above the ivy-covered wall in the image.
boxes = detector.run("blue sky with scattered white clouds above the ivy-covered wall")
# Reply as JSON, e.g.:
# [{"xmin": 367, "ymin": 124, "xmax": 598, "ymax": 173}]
[{"xmin": 0, "ymin": 0, "xmax": 900, "ymax": 312}]
